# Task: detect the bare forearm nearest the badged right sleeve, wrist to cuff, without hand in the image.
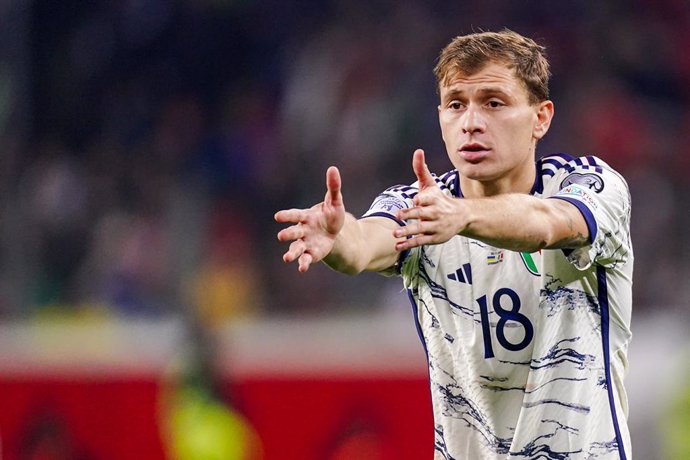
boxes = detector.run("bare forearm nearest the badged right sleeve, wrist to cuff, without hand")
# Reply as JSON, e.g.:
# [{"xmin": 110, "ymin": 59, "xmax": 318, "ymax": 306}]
[{"xmin": 459, "ymin": 194, "xmax": 588, "ymax": 252}]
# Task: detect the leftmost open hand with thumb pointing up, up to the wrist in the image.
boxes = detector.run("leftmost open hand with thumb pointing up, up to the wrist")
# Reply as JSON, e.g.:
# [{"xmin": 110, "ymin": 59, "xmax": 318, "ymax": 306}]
[{"xmin": 274, "ymin": 166, "xmax": 345, "ymax": 273}]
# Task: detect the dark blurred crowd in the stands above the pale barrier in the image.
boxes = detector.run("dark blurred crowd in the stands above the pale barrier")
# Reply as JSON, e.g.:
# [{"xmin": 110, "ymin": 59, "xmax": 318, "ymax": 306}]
[{"xmin": 0, "ymin": 0, "xmax": 690, "ymax": 324}]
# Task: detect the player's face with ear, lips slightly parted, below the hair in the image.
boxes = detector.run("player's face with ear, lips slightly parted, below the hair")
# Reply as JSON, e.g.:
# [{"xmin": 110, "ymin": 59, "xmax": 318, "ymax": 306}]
[{"xmin": 438, "ymin": 63, "xmax": 553, "ymax": 188}]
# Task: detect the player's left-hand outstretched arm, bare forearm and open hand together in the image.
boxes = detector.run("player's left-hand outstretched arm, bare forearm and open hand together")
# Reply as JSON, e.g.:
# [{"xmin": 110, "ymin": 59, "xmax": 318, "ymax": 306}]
[{"xmin": 275, "ymin": 166, "xmax": 398, "ymax": 275}]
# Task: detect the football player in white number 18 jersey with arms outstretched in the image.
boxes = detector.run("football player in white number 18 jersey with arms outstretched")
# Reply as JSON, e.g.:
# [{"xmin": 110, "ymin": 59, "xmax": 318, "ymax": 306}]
[{"xmin": 275, "ymin": 30, "xmax": 633, "ymax": 460}]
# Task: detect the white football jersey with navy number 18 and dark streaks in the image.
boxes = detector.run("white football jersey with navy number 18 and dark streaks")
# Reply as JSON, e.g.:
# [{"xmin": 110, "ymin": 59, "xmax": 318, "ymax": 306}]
[{"xmin": 363, "ymin": 154, "xmax": 633, "ymax": 460}]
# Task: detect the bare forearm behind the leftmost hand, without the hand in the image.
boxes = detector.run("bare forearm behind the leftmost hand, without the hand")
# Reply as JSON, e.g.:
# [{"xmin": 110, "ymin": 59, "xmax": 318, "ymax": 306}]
[{"xmin": 323, "ymin": 213, "xmax": 398, "ymax": 275}]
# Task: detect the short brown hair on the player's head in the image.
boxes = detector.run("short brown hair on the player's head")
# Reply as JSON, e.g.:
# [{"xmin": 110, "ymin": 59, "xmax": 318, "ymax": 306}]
[{"xmin": 434, "ymin": 29, "xmax": 551, "ymax": 104}]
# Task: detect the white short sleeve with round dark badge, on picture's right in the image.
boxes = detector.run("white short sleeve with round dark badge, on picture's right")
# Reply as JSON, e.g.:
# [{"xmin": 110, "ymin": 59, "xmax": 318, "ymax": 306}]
[{"xmin": 548, "ymin": 162, "xmax": 631, "ymax": 270}]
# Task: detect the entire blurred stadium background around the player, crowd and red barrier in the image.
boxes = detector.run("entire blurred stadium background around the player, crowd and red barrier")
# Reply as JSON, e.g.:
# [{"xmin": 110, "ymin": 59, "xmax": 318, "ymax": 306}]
[{"xmin": 0, "ymin": 0, "xmax": 690, "ymax": 460}]
